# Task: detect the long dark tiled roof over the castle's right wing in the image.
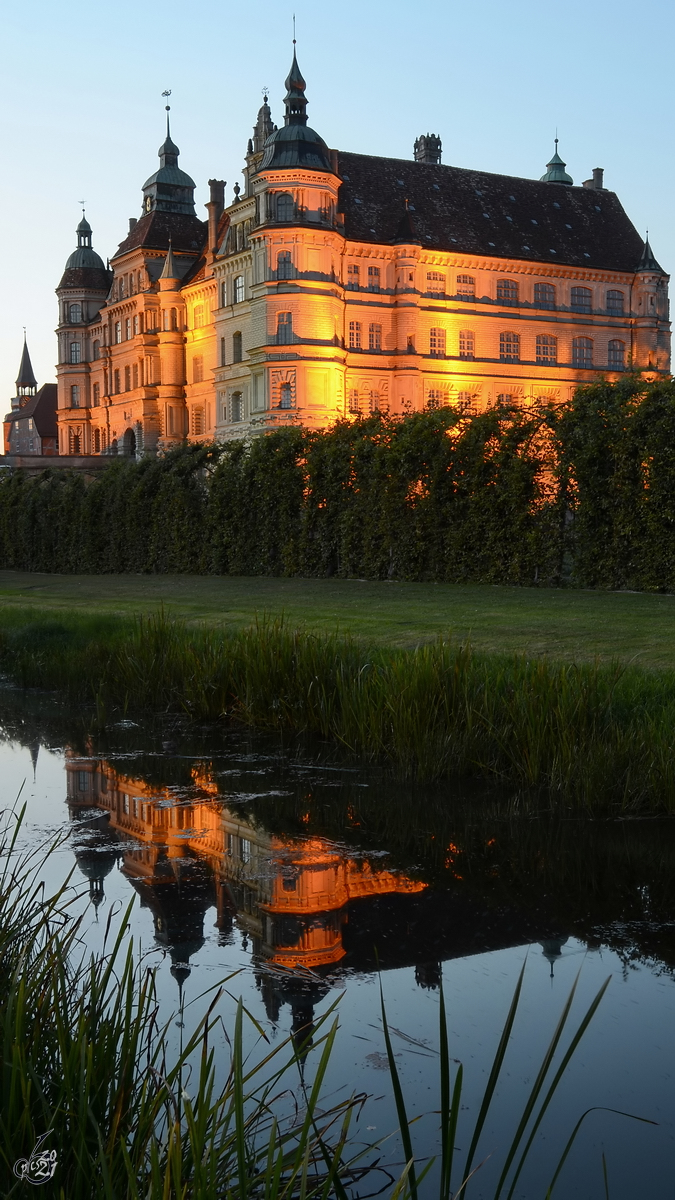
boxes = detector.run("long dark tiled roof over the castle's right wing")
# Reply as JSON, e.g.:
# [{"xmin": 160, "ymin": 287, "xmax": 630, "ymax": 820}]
[{"xmin": 339, "ymin": 151, "xmax": 644, "ymax": 271}]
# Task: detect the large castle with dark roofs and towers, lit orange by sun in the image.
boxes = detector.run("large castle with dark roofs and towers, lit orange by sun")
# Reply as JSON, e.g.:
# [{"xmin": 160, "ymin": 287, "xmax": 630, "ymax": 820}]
[{"xmin": 56, "ymin": 54, "xmax": 670, "ymax": 455}]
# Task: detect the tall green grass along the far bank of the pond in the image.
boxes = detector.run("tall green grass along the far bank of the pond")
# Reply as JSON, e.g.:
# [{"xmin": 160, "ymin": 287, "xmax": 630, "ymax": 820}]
[{"xmin": 0, "ymin": 608, "xmax": 675, "ymax": 812}]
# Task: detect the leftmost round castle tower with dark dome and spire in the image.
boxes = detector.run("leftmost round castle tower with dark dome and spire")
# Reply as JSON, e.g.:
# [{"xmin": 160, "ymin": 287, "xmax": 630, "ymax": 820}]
[{"xmin": 56, "ymin": 211, "xmax": 112, "ymax": 455}]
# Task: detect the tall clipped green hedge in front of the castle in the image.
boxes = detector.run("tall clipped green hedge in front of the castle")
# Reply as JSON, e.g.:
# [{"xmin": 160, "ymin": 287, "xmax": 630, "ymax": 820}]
[{"xmin": 0, "ymin": 377, "xmax": 675, "ymax": 589}]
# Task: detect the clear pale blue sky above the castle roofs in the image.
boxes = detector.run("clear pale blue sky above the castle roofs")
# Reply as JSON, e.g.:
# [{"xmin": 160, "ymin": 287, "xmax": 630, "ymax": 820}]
[{"xmin": 0, "ymin": 0, "xmax": 675, "ymax": 412}]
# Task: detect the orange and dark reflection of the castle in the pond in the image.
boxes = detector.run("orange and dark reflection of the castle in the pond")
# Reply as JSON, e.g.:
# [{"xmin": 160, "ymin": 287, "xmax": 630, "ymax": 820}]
[{"xmin": 66, "ymin": 755, "xmax": 564, "ymax": 1027}]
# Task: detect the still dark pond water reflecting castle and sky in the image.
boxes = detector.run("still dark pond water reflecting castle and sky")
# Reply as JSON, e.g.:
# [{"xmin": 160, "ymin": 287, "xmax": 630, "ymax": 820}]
[{"xmin": 0, "ymin": 691, "xmax": 675, "ymax": 1200}]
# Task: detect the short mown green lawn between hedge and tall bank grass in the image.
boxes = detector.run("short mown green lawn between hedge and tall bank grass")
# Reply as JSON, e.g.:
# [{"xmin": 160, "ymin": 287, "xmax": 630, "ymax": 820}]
[{"xmin": 0, "ymin": 571, "xmax": 675, "ymax": 667}]
